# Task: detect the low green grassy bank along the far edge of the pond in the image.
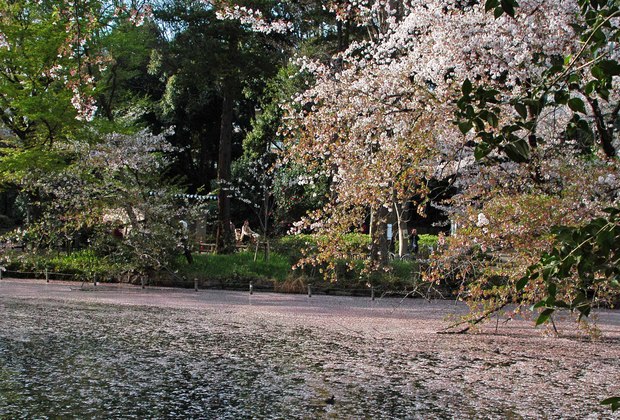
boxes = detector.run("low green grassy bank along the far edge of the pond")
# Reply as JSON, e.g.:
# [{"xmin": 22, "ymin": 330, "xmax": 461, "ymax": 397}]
[{"xmin": 0, "ymin": 234, "xmax": 436, "ymax": 294}]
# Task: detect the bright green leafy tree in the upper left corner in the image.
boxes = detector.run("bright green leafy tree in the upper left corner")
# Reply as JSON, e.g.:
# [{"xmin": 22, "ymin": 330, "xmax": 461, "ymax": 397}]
[{"xmin": 0, "ymin": 0, "xmax": 155, "ymax": 183}]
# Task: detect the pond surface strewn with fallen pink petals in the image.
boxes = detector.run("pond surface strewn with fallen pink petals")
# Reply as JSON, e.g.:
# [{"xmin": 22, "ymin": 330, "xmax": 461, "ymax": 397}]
[{"xmin": 0, "ymin": 280, "xmax": 620, "ymax": 419}]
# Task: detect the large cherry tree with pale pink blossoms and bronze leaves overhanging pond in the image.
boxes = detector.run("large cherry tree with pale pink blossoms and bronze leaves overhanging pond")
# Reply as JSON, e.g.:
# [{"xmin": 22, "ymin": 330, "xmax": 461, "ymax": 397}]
[{"xmin": 286, "ymin": 0, "xmax": 618, "ymax": 306}]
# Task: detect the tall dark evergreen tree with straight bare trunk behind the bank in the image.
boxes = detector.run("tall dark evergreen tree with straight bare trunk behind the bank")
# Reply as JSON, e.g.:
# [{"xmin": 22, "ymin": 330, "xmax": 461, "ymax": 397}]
[{"xmin": 149, "ymin": 1, "xmax": 285, "ymax": 252}]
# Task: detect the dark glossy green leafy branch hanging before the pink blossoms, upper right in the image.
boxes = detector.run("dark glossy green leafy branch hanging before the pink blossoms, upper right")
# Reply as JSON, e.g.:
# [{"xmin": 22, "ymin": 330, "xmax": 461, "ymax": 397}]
[{"xmin": 455, "ymin": 0, "xmax": 620, "ymax": 162}]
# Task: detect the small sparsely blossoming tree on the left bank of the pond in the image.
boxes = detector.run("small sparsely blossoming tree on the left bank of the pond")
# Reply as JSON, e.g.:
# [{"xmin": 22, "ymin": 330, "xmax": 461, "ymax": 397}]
[{"xmin": 12, "ymin": 131, "xmax": 205, "ymax": 274}]
